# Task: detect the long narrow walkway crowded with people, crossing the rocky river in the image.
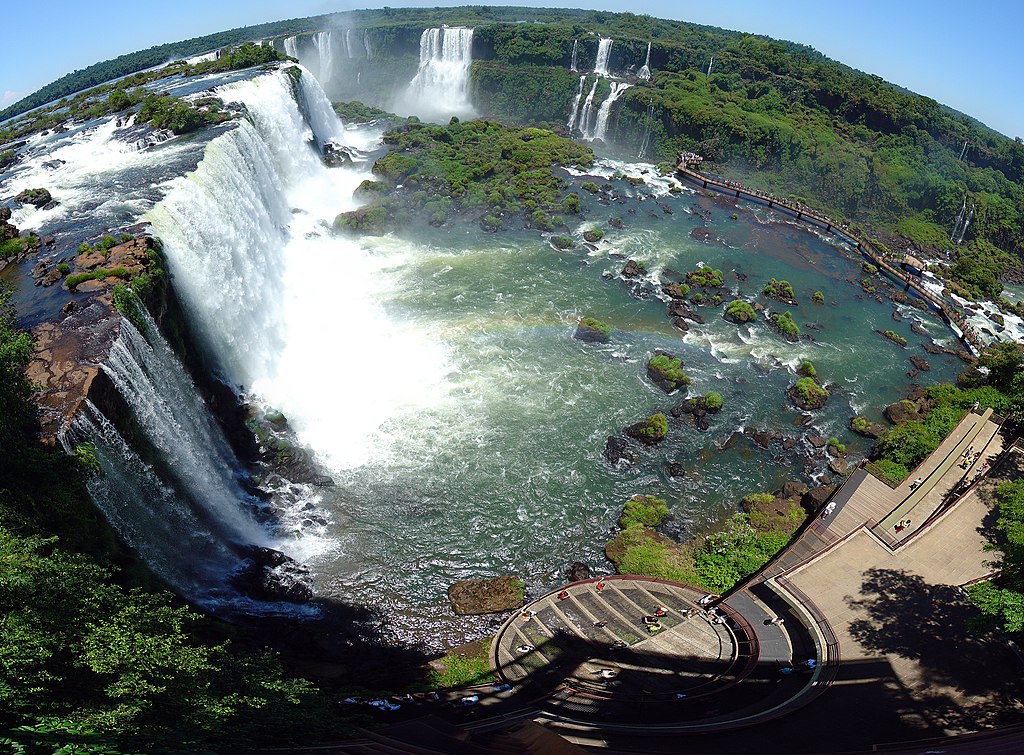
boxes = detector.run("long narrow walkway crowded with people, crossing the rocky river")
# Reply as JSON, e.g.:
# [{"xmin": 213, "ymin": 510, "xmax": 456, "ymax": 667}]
[{"xmin": 676, "ymin": 163, "xmax": 985, "ymax": 353}]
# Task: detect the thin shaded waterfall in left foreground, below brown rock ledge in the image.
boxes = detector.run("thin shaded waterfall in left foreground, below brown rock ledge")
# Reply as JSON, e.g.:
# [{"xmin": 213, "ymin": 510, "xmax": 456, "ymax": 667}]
[{"xmin": 61, "ymin": 305, "xmax": 308, "ymax": 613}]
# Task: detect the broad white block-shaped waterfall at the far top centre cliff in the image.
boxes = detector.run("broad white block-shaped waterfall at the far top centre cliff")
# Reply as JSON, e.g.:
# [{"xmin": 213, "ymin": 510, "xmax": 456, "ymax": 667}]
[{"xmin": 404, "ymin": 27, "xmax": 474, "ymax": 120}]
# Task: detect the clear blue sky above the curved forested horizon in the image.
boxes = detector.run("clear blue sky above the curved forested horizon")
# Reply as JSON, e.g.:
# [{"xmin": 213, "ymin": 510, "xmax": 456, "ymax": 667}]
[{"xmin": 0, "ymin": 0, "xmax": 1024, "ymax": 136}]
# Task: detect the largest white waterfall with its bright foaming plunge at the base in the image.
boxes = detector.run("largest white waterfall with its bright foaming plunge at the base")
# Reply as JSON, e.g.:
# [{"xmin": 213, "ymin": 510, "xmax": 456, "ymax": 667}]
[{"xmin": 148, "ymin": 67, "xmax": 450, "ymax": 469}]
